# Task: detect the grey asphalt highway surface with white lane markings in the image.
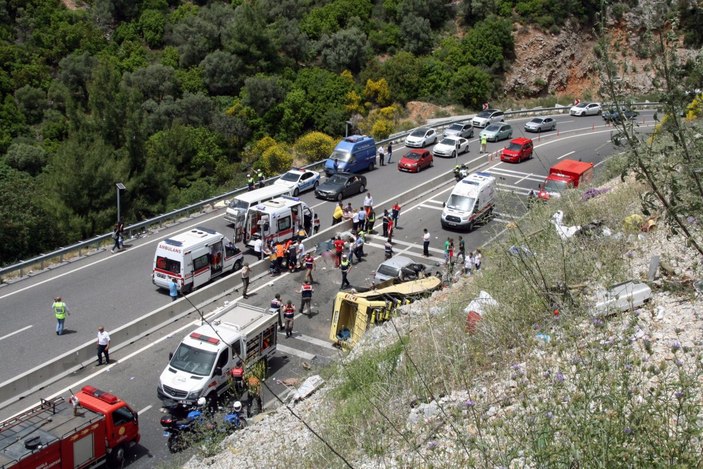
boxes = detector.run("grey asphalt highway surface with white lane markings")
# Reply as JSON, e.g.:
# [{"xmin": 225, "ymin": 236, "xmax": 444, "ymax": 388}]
[{"xmin": 0, "ymin": 113, "xmax": 651, "ymax": 467}]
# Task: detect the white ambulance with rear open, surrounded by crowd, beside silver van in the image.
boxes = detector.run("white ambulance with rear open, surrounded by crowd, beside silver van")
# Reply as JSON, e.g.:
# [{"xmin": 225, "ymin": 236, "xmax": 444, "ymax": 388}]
[{"xmin": 235, "ymin": 196, "xmax": 314, "ymax": 248}]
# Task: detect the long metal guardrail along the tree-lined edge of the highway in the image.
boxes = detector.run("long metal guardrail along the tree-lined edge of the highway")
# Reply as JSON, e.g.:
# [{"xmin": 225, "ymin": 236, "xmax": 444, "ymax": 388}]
[{"xmin": 0, "ymin": 102, "xmax": 660, "ymax": 283}]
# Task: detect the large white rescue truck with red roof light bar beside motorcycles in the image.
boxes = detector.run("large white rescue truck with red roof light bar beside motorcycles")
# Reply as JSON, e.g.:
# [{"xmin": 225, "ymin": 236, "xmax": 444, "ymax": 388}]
[{"xmin": 157, "ymin": 302, "xmax": 278, "ymax": 405}]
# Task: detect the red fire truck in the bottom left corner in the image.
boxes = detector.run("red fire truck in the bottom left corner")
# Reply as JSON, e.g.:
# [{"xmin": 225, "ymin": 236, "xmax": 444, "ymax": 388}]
[{"xmin": 0, "ymin": 386, "xmax": 140, "ymax": 469}]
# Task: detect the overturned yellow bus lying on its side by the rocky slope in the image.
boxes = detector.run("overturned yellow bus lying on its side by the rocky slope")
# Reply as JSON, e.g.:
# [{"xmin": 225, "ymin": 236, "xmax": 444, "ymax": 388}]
[{"xmin": 330, "ymin": 276, "xmax": 442, "ymax": 348}]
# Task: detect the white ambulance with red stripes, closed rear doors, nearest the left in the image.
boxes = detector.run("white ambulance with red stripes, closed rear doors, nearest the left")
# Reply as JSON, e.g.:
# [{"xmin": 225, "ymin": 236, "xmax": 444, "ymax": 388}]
[{"xmin": 151, "ymin": 226, "xmax": 244, "ymax": 293}]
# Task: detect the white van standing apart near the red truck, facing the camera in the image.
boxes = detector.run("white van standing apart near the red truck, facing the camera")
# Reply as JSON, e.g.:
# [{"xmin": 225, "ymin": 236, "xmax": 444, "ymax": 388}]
[{"xmin": 442, "ymin": 172, "xmax": 496, "ymax": 231}]
